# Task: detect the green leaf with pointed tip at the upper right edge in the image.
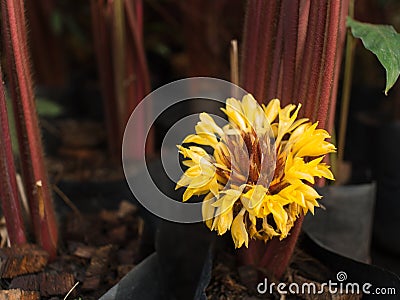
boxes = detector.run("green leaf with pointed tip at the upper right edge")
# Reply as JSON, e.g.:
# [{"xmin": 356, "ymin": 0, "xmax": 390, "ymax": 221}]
[{"xmin": 347, "ymin": 17, "xmax": 400, "ymax": 95}]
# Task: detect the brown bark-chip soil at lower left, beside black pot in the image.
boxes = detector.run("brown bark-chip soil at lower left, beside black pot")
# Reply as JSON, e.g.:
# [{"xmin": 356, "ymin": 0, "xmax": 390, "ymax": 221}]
[{"xmin": 1, "ymin": 202, "xmax": 143, "ymax": 300}]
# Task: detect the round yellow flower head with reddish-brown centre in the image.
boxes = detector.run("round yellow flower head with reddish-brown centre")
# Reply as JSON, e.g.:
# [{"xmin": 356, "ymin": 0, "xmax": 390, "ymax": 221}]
[{"xmin": 176, "ymin": 94, "xmax": 336, "ymax": 248}]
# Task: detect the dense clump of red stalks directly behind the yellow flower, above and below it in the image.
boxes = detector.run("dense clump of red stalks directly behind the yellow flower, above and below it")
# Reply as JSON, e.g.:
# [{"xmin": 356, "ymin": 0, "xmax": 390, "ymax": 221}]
[{"xmin": 241, "ymin": 0, "xmax": 348, "ymax": 279}]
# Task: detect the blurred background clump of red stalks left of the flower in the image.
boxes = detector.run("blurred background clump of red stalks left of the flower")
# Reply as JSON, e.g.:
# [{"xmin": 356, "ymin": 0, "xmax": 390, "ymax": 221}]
[{"xmin": 91, "ymin": 0, "xmax": 153, "ymax": 160}]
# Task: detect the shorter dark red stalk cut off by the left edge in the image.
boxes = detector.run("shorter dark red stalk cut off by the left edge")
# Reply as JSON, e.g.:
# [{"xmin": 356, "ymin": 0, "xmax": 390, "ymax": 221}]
[{"xmin": 0, "ymin": 68, "xmax": 26, "ymax": 245}]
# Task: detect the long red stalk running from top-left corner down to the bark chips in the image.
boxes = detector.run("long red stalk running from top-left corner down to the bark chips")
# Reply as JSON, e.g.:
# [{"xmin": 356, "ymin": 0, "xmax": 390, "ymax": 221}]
[{"xmin": 1, "ymin": 0, "xmax": 58, "ymax": 258}]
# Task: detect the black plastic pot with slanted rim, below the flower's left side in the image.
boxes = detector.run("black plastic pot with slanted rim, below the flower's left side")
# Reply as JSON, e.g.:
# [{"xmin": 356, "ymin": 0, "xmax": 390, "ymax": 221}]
[{"xmin": 100, "ymin": 222, "xmax": 213, "ymax": 300}]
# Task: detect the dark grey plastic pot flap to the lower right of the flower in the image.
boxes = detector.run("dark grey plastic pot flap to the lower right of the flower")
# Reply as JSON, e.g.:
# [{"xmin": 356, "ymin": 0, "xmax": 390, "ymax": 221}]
[{"xmin": 303, "ymin": 183, "xmax": 375, "ymax": 263}]
